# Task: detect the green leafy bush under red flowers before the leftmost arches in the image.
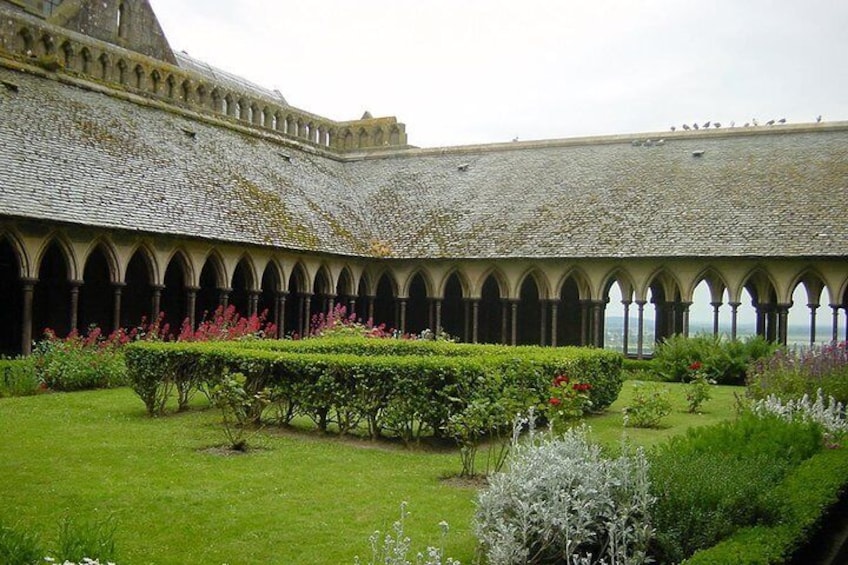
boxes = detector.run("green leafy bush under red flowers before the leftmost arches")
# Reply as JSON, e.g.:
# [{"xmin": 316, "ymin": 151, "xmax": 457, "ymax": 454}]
[{"xmin": 32, "ymin": 338, "xmax": 127, "ymax": 391}]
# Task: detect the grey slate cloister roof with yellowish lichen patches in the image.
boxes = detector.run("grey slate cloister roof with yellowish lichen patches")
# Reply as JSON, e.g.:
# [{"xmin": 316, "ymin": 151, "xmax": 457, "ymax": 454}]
[{"xmin": 0, "ymin": 62, "xmax": 848, "ymax": 258}]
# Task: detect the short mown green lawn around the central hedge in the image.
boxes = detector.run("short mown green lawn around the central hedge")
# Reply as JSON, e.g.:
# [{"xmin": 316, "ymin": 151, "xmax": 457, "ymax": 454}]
[{"xmin": 0, "ymin": 383, "xmax": 741, "ymax": 565}]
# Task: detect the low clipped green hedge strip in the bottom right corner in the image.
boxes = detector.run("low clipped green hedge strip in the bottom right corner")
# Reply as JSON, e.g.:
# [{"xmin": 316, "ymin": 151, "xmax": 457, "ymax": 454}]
[{"xmin": 684, "ymin": 448, "xmax": 848, "ymax": 565}]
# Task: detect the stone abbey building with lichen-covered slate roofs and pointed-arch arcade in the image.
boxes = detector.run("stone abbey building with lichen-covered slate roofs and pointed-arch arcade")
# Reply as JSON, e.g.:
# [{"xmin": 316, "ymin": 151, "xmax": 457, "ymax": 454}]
[{"xmin": 0, "ymin": 0, "xmax": 848, "ymax": 354}]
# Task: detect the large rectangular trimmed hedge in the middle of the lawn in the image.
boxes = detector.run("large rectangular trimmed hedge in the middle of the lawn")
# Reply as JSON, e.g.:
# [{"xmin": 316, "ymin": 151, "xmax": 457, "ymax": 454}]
[{"xmin": 125, "ymin": 339, "xmax": 622, "ymax": 439}]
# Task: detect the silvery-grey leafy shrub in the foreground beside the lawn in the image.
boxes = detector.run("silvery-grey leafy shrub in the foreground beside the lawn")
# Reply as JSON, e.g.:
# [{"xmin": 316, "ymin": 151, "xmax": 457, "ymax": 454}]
[{"xmin": 474, "ymin": 427, "xmax": 653, "ymax": 565}]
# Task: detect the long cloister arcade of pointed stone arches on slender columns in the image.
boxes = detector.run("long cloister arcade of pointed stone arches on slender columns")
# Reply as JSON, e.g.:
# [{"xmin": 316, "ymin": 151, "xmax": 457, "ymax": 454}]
[{"xmin": 0, "ymin": 224, "xmax": 848, "ymax": 356}]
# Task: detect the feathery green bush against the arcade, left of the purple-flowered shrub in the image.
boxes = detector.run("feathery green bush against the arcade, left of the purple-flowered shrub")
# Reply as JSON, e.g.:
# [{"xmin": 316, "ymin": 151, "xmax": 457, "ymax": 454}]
[{"xmin": 653, "ymin": 334, "xmax": 779, "ymax": 385}]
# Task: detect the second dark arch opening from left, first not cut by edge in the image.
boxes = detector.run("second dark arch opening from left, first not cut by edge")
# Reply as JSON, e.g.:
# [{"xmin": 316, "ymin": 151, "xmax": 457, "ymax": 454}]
[{"xmin": 33, "ymin": 241, "xmax": 71, "ymax": 339}]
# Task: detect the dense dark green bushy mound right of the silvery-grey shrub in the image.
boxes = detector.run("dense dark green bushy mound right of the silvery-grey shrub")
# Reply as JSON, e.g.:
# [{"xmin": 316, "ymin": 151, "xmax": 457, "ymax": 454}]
[{"xmin": 650, "ymin": 414, "xmax": 822, "ymax": 563}]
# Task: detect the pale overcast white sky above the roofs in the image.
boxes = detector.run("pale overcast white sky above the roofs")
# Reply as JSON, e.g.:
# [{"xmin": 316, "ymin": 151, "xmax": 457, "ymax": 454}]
[{"xmin": 151, "ymin": 0, "xmax": 848, "ymax": 147}]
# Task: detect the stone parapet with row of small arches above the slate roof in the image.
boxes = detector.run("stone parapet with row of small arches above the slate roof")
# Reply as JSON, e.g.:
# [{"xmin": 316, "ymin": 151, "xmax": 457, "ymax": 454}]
[{"xmin": 0, "ymin": 2, "xmax": 407, "ymax": 153}]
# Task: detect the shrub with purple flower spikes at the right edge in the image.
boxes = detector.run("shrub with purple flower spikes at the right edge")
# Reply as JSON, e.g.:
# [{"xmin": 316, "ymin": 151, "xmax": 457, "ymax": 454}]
[{"xmin": 747, "ymin": 342, "xmax": 848, "ymax": 404}]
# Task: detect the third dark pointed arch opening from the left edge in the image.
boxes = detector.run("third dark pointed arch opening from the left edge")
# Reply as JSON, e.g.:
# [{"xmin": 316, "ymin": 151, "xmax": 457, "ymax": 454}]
[{"xmin": 77, "ymin": 246, "xmax": 115, "ymax": 334}]
